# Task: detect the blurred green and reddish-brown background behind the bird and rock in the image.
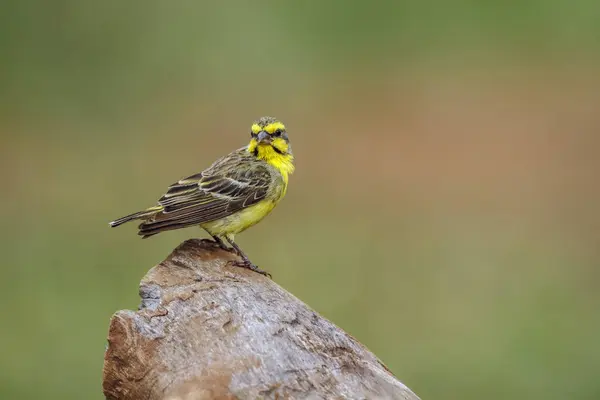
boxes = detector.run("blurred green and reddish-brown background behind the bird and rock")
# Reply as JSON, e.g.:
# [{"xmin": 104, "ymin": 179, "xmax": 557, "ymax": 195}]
[{"xmin": 0, "ymin": 0, "xmax": 600, "ymax": 400}]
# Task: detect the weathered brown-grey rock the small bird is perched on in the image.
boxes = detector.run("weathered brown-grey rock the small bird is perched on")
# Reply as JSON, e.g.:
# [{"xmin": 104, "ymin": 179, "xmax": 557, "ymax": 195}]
[{"xmin": 103, "ymin": 239, "xmax": 418, "ymax": 400}]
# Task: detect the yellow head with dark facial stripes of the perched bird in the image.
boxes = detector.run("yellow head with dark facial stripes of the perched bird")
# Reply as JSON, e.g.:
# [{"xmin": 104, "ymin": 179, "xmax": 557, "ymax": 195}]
[{"xmin": 248, "ymin": 117, "xmax": 292, "ymax": 159}]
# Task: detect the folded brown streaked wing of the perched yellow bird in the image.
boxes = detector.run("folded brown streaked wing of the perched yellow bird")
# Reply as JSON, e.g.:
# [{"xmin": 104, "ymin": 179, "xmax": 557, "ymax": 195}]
[{"xmin": 139, "ymin": 151, "xmax": 271, "ymax": 237}]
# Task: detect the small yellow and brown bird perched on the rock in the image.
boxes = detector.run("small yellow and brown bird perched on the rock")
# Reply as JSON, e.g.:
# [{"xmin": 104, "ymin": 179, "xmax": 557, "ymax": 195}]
[{"xmin": 110, "ymin": 117, "xmax": 295, "ymax": 277}]
